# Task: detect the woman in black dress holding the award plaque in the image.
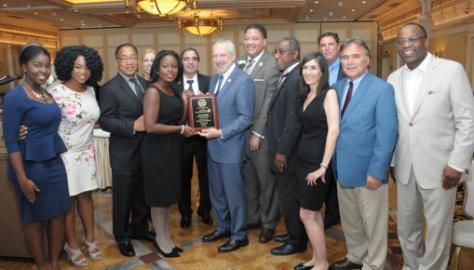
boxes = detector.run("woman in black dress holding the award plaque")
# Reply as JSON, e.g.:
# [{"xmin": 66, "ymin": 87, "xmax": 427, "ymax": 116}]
[{"xmin": 142, "ymin": 50, "xmax": 194, "ymax": 257}]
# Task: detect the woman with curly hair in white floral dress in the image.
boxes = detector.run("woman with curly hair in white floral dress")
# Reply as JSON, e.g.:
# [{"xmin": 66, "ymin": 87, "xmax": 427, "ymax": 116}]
[{"xmin": 48, "ymin": 46, "xmax": 103, "ymax": 267}]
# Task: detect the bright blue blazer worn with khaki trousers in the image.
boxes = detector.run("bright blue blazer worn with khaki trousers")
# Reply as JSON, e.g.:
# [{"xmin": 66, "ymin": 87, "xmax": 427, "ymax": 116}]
[{"xmin": 333, "ymin": 72, "xmax": 397, "ymax": 187}]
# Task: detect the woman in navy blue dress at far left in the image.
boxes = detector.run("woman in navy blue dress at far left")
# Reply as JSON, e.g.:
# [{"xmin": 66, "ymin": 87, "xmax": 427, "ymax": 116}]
[{"xmin": 3, "ymin": 45, "xmax": 70, "ymax": 269}]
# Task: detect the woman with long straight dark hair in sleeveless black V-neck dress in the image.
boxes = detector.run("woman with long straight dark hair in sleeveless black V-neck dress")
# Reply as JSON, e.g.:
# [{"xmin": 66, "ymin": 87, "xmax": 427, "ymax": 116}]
[{"xmin": 294, "ymin": 53, "xmax": 339, "ymax": 270}]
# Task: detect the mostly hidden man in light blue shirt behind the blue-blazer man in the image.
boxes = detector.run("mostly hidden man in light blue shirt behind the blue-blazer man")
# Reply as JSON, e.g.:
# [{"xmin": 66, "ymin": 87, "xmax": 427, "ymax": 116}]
[{"xmin": 318, "ymin": 32, "xmax": 347, "ymax": 229}]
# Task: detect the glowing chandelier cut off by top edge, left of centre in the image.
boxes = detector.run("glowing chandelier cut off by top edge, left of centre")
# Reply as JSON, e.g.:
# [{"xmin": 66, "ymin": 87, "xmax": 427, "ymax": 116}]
[{"xmin": 125, "ymin": 0, "xmax": 196, "ymax": 16}]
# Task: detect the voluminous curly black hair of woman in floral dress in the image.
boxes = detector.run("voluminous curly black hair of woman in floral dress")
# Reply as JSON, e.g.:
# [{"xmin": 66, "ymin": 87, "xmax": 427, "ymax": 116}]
[{"xmin": 54, "ymin": 45, "xmax": 104, "ymax": 86}]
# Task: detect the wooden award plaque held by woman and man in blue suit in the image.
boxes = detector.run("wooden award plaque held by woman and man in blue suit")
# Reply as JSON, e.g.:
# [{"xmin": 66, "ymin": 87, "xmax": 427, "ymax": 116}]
[{"xmin": 188, "ymin": 94, "xmax": 219, "ymax": 130}]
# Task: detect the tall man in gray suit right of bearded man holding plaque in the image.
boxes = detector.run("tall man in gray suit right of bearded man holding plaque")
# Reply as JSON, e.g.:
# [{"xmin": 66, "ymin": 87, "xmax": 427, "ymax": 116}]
[{"xmin": 239, "ymin": 23, "xmax": 279, "ymax": 243}]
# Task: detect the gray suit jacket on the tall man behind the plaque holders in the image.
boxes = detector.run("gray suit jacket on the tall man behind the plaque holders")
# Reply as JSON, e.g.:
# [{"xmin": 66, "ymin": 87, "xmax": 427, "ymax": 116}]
[{"xmin": 241, "ymin": 50, "xmax": 280, "ymax": 136}]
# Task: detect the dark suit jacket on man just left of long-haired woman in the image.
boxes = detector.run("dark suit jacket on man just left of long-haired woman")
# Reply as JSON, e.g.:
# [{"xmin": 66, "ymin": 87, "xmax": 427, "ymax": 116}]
[{"xmin": 266, "ymin": 65, "xmax": 301, "ymax": 157}]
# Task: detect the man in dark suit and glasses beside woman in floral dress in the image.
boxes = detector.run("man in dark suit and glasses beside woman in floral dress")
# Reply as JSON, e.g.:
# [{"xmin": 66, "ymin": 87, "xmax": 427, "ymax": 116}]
[{"xmin": 99, "ymin": 43, "xmax": 154, "ymax": 256}]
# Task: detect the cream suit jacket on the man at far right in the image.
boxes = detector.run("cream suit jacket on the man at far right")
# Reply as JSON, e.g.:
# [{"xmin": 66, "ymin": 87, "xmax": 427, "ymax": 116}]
[{"xmin": 388, "ymin": 56, "xmax": 474, "ymax": 189}]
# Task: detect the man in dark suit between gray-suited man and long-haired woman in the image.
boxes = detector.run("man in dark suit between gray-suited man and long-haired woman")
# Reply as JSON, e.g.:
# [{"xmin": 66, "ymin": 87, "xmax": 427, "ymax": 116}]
[{"xmin": 266, "ymin": 38, "xmax": 308, "ymax": 255}]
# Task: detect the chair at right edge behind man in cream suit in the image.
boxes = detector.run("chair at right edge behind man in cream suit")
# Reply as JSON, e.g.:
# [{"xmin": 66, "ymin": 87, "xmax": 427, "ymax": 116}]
[{"xmin": 453, "ymin": 161, "xmax": 474, "ymax": 270}]
